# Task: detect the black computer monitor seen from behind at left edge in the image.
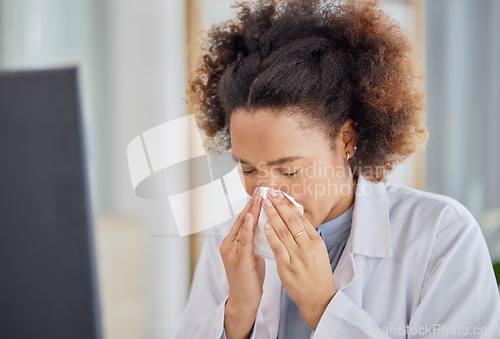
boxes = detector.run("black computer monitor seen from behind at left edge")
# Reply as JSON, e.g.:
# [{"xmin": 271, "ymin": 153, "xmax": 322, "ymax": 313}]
[{"xmin": 0, "ymin": 68, "xmax": 102, "ymax": 339}]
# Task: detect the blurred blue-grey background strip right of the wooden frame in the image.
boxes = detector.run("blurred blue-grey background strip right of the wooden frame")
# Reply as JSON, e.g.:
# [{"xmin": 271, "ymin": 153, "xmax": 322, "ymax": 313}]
[{"xmin": 425, "ymin": 0, "xmax": 500, "ymax": 262}]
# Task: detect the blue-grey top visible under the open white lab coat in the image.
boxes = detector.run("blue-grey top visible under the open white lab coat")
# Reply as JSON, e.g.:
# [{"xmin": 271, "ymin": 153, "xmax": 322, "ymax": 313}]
[{"xmin": 278, "ymin": 204, "xmax": 354, "ymax": 339}]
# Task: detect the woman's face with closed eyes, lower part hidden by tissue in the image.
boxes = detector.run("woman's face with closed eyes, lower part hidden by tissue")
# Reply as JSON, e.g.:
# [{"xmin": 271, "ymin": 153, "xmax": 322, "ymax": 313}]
[{"xmin": 230, "ymin": 109, "xmax": 355, "ymax": 227}]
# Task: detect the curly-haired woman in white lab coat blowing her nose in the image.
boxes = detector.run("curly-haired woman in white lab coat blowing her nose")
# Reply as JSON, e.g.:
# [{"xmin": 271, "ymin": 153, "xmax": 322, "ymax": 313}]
[{"xmin": 177, "ymin": 0, "xmax": 500, "ymax": 338}]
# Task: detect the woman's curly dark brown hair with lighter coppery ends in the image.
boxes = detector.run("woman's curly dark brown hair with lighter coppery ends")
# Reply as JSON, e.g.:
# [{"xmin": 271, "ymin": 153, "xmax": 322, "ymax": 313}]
[{"xmin": 187, "ymin": 0, "xmax": 427, "ymax": 182}]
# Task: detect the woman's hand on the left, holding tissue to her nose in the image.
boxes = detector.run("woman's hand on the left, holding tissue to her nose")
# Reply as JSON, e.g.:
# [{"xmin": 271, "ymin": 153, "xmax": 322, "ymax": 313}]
[{"xmin": 220, "ymin": 187, "xmax": 266, "ymax": 314}]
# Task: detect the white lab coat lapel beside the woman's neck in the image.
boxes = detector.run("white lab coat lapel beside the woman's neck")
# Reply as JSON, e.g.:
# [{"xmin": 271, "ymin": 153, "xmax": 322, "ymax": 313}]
[{"xmin": 346, "ymin": 176, "xmax": 392, "ymax": 258}]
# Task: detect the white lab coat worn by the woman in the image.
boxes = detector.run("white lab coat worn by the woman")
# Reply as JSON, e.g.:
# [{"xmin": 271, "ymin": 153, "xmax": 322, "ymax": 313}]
[{"xmin": 175, "ymin": 177, "xmax": 500, "ymax": 339}]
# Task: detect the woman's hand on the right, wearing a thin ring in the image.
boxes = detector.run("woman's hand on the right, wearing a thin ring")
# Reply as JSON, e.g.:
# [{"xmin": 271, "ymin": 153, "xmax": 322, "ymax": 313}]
[{"xmin": 263, "ymin": 189, "xmax": 337, "ymax": 329}]
